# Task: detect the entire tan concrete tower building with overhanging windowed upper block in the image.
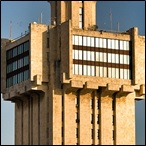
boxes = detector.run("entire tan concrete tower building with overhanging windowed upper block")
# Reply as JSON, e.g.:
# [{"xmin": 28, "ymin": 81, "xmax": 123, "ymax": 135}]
[{"xmin": 1, "ymin": 1, "xmax": 145, "ymax": 145}]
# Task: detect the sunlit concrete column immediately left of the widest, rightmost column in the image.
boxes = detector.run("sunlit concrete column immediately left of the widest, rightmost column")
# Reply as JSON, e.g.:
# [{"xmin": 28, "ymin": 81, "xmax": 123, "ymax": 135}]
[{"xmin": 99, "ymin": 88, "xmax": 113, "ymax": 145}]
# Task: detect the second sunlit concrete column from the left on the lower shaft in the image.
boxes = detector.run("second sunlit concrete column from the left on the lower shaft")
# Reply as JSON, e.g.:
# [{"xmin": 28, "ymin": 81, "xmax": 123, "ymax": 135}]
[{"xmin": 64, "ymin": 92, "xmax": 76, "ymax": 145}]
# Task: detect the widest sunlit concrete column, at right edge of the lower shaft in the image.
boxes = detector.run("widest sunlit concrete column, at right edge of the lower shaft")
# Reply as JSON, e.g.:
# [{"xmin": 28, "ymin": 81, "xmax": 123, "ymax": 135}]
[{"xmin": 115, "ymin": 92, "xmax": 135, "ymax": 145}]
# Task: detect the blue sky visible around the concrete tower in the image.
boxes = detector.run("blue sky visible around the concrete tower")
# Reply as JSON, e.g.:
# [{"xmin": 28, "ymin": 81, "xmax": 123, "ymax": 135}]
[{"xmin": 1, "ymin": 1, "xmax": 145, "ymax": 145}]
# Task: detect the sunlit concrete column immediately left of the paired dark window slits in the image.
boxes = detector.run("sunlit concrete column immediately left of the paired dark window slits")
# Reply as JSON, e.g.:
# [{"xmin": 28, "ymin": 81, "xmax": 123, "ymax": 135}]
[{"xmin": 79, "ymin": 90, "xmax": 92, "ymax": 145}]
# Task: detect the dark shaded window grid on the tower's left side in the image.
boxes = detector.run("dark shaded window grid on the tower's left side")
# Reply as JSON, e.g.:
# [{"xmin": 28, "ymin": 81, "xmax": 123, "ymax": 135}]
[{"xmin": 6, "ymin": 41, "xmax": 29, "ymax": 88}]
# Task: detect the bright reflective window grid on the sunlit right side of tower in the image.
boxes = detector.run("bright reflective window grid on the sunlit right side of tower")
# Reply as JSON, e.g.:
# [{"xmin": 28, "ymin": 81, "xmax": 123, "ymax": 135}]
[{"xmin": 73, "ymin": 35, "xmax": 131, "ymax": 79}]
